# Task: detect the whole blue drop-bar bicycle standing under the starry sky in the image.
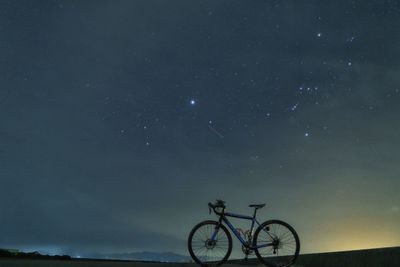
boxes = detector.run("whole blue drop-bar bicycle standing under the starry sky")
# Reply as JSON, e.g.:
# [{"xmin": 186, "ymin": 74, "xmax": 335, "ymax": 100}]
[{"xmin": 188, "ymin": 200, "xmax": 300, "ymax": 267}]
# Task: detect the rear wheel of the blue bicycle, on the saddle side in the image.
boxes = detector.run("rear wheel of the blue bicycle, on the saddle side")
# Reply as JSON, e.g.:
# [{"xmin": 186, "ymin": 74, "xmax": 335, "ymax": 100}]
[{"xmin": 253, "ymin": 220, "xmax": 300, "ymax": 267}]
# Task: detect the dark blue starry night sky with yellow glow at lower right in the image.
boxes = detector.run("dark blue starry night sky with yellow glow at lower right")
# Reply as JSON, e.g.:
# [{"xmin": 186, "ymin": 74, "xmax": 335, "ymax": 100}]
[{"xmin": 0, "ymin": 0, "xmax": 400, "ymax": 260}]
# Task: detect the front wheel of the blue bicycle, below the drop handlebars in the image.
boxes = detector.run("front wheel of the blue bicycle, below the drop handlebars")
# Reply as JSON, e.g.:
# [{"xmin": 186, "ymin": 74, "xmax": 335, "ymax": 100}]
[{"xmin": 188, "ymin": 221, "xmax": 232, "ymax": 267}]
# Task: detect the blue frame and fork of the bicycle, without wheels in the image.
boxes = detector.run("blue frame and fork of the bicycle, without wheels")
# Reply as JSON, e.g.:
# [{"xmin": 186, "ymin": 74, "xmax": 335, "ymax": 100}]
[{"xmin": 211, "ymin": 211, "xmax": 273, "ymax": 250}]
